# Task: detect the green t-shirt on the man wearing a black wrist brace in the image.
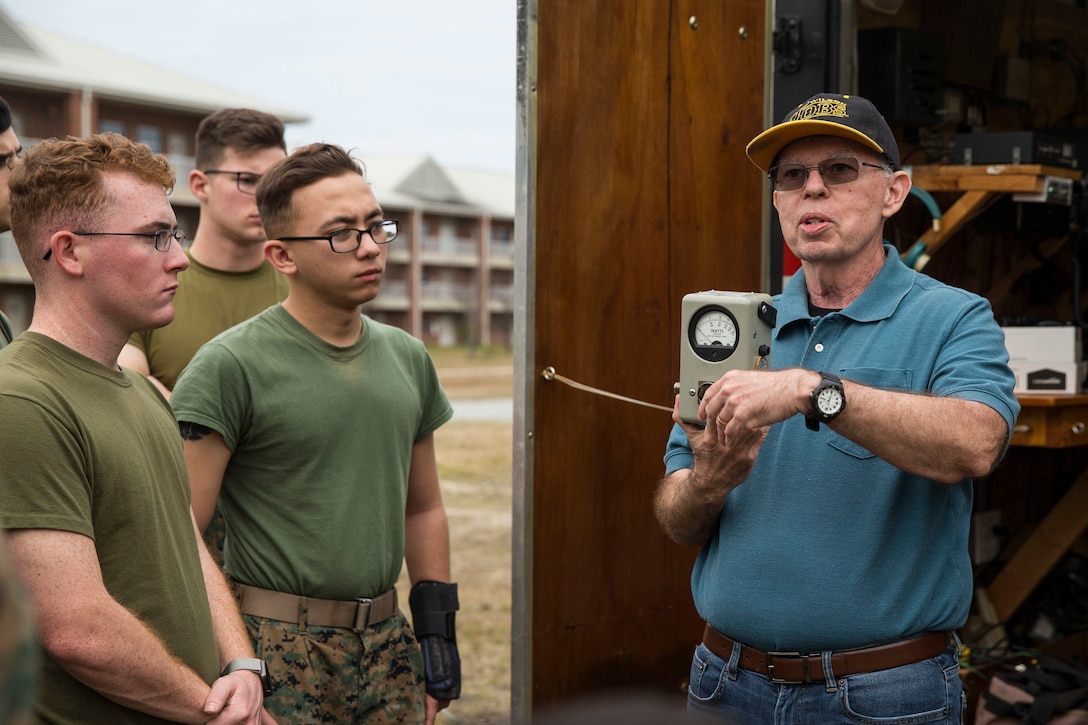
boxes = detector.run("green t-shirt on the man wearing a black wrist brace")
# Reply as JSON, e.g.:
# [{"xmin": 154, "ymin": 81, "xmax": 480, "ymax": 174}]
[{"xmin": 171, "ymin": 305, "xmax": 453, "ymax": 600}]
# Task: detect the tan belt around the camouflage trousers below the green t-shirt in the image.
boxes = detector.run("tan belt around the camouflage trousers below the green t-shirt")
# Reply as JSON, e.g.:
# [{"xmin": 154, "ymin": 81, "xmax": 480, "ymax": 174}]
[{"xmin": 234, "ymin": 582, "xmax": 397, "ymax": 629}]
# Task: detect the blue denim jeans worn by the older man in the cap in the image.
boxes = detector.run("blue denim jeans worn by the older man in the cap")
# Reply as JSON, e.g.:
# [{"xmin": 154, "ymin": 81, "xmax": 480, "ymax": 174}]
[{"xmin": 688, "ymin": 643, "xmax": 967, "ymax": 725}]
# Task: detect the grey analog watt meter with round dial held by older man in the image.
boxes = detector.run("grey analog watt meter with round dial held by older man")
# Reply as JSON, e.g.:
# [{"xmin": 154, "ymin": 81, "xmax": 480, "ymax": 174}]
[{"xmin": 677, "ymin": 290, "xmax": 776, "ymax": 423}]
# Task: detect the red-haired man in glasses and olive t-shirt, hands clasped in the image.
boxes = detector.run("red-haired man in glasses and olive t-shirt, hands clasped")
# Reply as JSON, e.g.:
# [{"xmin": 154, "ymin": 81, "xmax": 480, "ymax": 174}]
[{"xmin": 0, "ymin": 134, "xmax": 274, "ymax": 725}]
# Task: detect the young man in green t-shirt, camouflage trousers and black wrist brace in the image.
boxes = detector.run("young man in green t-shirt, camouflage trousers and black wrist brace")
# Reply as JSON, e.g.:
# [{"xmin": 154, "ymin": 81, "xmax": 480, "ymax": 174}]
[{"xmin": 171, "ymin": 144, "xmax": 460, "ymax": 725}]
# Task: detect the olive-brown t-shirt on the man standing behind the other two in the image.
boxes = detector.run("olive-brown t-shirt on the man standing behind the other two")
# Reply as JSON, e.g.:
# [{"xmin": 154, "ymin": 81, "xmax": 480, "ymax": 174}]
[{"xmin": 128, "ymin": 253, "xmax": 287, "ymax": 390}]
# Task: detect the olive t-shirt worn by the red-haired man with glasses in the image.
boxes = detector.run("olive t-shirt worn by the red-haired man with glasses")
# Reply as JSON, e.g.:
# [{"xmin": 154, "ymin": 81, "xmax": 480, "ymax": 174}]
[{"xmin": 0, "ymin": 332, "xmax": 219, "ymax": 724}]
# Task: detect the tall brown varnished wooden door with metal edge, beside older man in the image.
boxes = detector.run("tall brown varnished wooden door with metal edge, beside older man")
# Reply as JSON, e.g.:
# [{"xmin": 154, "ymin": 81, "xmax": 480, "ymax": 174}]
[{"xmin": 512, "ymin": 0, "xmax": 768, "ymax": 717}]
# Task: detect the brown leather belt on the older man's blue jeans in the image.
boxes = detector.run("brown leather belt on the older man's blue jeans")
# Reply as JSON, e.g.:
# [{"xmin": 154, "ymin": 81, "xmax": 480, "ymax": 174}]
[{"xmin": 703, "ymin": 625, "xmax": 951, "ymax": 685}]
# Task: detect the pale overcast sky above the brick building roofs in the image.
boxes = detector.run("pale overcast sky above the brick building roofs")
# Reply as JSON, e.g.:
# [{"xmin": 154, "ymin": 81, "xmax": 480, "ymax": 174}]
[{"xmin": 0, "ymin": 0, "xmax": 517, "ymax": 172}]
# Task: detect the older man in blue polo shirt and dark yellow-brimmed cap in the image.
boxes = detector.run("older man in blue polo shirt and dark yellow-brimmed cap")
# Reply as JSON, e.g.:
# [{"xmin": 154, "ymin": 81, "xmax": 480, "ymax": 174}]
[{"xmin": 655, "ymin": 94, "xmax": 1019, "ymax": 725}]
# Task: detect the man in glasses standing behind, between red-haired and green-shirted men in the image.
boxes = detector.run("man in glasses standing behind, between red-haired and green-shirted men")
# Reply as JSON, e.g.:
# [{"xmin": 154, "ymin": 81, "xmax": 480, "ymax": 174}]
[{"xmin": 121, "ymin": 108, "xmax": 287, "ymax": 563}]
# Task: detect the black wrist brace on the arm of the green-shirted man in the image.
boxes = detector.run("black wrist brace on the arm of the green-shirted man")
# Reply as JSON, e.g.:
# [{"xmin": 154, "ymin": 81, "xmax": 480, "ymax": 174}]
[{"xmin": 408, "ymin": 581, "xmax": 461, "ymax": 700}]
